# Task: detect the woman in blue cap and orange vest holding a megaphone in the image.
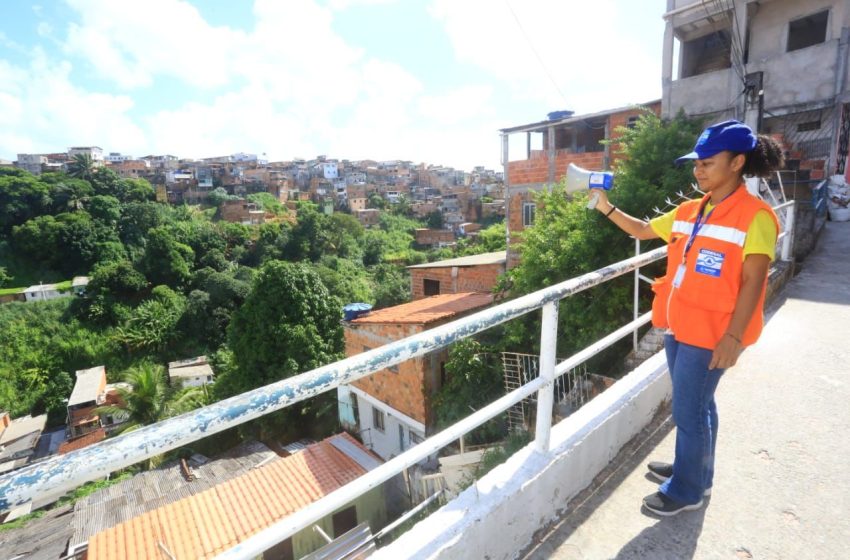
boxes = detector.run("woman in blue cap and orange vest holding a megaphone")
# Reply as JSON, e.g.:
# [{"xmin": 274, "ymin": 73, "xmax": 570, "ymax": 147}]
[{"xmin": 596, "ymin": 120, "xmax": 782, "ymax": 516}]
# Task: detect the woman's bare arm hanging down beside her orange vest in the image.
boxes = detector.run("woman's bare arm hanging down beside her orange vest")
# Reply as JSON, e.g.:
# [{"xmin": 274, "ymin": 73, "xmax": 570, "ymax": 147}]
[{"xmin": 708, "ymin": 254, "xmax": 770, "ymax": 369}]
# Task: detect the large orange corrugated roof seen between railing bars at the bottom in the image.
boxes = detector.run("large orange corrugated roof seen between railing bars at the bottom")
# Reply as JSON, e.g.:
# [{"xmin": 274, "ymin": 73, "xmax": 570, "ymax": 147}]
[{"xmin": 88, "ymin": 434, "xmax": 380, "ymax": 560}]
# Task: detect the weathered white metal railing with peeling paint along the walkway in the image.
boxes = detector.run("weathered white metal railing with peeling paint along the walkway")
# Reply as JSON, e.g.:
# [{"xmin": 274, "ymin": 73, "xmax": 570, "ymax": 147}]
[{"xmin": 0, "ymin": 200, "xmax": 795, "ymax": 559}]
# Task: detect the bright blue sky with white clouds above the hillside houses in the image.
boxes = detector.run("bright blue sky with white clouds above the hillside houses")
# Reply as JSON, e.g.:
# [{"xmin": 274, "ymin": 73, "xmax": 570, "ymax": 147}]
[{"xmin": 0, "ymin": 0, "xmax": 666, "ymax": 169}]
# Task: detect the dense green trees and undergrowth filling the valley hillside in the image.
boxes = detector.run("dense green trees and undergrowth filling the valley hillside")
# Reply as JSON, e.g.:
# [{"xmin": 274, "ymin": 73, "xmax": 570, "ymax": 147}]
[{"xmin": 0, "ymin": 164, "xmax": 504, "ymax": 436}]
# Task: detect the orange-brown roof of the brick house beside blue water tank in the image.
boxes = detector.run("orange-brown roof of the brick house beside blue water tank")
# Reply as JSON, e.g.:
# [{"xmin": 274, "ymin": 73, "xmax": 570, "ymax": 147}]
[{"xmin": 351, "ymin": 292, "xmax": 493, "ymax": 325}]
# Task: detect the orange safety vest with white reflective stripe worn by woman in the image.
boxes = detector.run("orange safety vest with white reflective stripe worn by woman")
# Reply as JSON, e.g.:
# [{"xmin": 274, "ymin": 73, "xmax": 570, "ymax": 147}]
[{"xmin": 652, "ymin": 185, "xmax": 779, "ymax": 350}]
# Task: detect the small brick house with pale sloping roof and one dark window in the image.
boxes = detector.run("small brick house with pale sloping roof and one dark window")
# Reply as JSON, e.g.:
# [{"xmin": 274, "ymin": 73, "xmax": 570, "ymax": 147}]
[{"xmin": 407, "ymin": 251, "xmax": 507, "ymax": 300}]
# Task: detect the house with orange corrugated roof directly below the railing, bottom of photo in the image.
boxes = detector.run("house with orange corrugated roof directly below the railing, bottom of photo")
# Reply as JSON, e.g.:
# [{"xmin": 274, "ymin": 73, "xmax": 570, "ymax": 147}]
[{"xmin": 87, "ymin": 434, "xmax": 387, "ymax": 560}]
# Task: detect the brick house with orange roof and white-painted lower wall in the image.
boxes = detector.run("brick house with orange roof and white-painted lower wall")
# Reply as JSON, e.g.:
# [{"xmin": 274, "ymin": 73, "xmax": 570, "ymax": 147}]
[{"xmin": 338, "ymin": 292, "xmax": 493, "ymax": 459}]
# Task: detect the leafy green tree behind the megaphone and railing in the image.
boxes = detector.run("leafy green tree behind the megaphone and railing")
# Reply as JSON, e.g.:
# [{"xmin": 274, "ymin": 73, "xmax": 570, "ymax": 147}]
[{"xmin": 503, "ymin": 113, "xmax": 701, "ymax": 355}]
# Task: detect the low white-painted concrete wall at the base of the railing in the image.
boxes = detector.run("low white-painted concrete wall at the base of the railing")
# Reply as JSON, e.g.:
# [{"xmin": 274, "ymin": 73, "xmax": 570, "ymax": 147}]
[{"xmin": 372, "ymin": 352, "xmax": 671, "ymax": 560}]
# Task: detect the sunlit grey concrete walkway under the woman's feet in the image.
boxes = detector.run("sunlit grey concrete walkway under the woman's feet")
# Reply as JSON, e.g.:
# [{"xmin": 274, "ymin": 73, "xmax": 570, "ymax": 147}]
[{"xmin": 523, "ymin": 222, "xmax": 850, "ymax": 560}]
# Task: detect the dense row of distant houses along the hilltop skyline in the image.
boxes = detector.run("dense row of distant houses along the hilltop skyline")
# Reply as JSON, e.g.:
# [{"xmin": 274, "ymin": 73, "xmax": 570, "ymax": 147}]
[{"xmin": 0, "ymin": 146, "xmax": 505, "ymax": 231}]
